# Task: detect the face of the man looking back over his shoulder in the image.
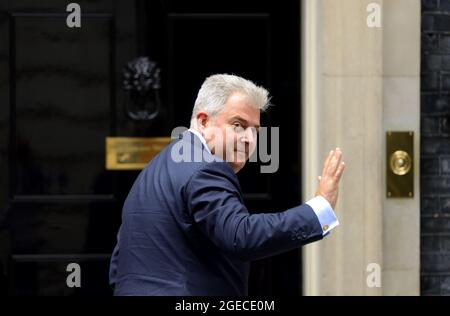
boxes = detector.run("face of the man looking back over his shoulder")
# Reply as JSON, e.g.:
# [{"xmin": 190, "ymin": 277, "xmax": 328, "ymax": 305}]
[{"xmin": 197, "ymin": 93, "xmax": 260, "ymax": 173}]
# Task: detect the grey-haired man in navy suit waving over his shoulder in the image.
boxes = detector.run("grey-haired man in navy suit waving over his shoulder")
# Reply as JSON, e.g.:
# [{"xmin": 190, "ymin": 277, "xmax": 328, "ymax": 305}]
[{"xmin": 110, "ymin": 75, "xmax": 345, "ymax": 295}]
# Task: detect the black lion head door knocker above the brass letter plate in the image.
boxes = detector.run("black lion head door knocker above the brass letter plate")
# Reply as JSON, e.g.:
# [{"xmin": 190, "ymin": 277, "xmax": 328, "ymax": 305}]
[{"xmin": 122, "ymin": 57, "xmax": 161, "ymax": 121}]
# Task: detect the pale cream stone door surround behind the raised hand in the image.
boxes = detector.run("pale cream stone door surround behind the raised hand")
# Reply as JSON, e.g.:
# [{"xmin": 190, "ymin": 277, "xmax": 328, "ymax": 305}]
[{"xmin": 302, "ymin": 0, "xmax": 420, "ymax": 295}]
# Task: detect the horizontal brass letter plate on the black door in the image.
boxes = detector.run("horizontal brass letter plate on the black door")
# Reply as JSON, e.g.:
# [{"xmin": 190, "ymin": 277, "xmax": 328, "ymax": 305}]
[{"xmin": 106, "ymin": 137, "xmax": 172, "ymax": 170}]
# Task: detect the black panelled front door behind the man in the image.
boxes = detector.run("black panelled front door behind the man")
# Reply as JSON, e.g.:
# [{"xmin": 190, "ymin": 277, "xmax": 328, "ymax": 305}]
[{"xmin": 0, "ymin": 0, "xmax": 301, "ymax": 295}]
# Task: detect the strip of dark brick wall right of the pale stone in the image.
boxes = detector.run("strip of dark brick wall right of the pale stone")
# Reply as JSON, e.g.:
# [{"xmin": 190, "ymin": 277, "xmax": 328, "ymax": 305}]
[{"xmin": 420, "ymin": 0, "xmax": 450, "ymax": 295}]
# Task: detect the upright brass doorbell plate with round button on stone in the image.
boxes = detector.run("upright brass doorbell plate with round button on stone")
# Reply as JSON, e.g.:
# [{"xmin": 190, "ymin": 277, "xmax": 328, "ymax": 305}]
[{"xmin": 386, "ymin": 132, "xmax": 414, "ymax": 198}]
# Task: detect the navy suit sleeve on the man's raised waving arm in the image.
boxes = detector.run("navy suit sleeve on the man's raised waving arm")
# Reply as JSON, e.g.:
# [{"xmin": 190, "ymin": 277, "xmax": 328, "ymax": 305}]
[{"xmin": 185, "ymin": 162, "xmax": 323, "ymax": 261}]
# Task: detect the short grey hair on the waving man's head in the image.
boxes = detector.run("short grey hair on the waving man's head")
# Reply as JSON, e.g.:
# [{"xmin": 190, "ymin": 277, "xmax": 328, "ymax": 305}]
[{"xmin": 191, "ymin": 74, "xmax": 270, "ymax": 127}]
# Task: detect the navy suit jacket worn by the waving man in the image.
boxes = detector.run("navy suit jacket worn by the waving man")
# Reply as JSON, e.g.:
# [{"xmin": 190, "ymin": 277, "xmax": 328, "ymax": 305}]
[{"xmin": 110, "ymin": 131, "xmax": 322, "ymax": 295}]
